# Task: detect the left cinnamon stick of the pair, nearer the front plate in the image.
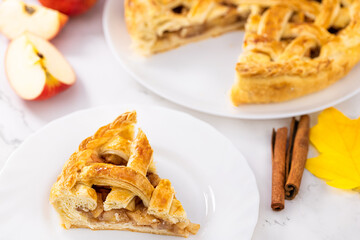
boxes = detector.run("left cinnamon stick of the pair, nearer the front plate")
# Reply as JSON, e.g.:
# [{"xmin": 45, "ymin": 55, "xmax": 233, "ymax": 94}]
[{"xmin": 271, "ymin": 127, "xmax": 288, "ymax": 211}]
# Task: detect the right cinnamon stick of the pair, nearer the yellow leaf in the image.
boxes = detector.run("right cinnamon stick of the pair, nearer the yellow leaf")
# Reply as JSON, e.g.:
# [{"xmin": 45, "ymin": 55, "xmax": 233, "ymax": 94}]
[{"xmin": 285, "ymin": 115, "xmax": 310, "ymax": 200}]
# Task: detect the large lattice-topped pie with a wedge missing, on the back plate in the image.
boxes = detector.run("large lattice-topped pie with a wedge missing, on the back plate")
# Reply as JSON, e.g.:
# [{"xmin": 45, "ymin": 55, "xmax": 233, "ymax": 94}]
[{"xmin": 125, "ymin": 0, "xmax": 360, "ymax": 105}]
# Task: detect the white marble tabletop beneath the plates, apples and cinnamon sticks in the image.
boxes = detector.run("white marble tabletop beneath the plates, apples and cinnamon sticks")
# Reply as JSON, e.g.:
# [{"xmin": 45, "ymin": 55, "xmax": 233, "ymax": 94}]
[{"xmin": 0, "ymin": 1, "xmax": 360, "ymax": 240}]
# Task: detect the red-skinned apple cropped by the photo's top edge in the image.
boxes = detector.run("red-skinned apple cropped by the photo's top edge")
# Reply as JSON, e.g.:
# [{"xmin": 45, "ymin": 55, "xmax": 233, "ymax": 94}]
[{"xmin": 39, "ymin": 0, "xmax": 97, "ymax": 16}]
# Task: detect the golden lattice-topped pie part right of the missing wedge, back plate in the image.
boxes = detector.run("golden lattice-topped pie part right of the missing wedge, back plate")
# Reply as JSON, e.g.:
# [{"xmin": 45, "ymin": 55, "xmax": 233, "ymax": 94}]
[{"xmin": 231, "ymin": 0, "xmax": 360, "ymax": 105}]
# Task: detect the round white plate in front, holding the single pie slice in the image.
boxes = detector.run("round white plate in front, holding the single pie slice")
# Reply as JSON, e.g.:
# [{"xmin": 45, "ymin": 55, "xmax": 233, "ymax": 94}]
[{"xmin": 0, "ymin": 105, "xmax": 259, "ymax": 240}]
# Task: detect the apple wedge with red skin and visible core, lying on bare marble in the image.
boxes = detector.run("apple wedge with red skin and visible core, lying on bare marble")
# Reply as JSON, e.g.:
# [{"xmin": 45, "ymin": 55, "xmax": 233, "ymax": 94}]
[{"xmin": 5, "ymin": 33, "xmax": 76, "ymax": 100}]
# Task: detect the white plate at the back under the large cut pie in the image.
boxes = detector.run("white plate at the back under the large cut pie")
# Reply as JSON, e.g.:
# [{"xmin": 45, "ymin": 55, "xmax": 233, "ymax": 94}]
[{"xmin": 103, "ymin": 0, "xmax": 360, "ymax": 119}]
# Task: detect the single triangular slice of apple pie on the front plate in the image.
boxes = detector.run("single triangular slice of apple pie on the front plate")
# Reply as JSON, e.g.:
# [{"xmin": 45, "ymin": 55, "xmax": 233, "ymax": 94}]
[{"xmin": 50, "ymin": 111, "xmax": 200, "ymax": 237}]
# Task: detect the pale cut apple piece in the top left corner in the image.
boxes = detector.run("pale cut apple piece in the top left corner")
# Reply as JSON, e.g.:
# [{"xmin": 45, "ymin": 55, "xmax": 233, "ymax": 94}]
[{"xmin": 0, "ymin": 0, "xmax": 68, "ymax": 39}]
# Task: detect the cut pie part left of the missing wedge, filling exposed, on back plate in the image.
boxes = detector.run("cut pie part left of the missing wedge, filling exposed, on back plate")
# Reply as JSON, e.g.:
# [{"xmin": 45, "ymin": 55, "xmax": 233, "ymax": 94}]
[{"xmin": 124, "ymin": 0, "xmax": 249, "ymax": 55}]
